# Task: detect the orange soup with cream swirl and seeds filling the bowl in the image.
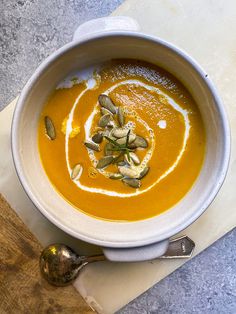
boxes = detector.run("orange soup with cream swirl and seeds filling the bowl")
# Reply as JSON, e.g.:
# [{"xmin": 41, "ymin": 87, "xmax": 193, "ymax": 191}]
[{"xmin": 38, "ymin": 59, "xmax": 205, "ymax": 221}]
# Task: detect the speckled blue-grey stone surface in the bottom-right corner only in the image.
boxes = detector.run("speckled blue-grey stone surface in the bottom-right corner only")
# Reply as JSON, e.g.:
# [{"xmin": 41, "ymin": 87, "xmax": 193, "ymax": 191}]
[{"xmin": 119, "ymin": 229, "xmax": 236, "ymax": 314}]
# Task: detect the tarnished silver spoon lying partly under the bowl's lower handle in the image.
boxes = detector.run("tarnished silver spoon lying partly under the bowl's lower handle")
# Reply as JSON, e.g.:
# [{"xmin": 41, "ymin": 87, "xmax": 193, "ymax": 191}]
[{"xmin": 39, "ymin": 236, "xmax": 195, "ymax": 286}]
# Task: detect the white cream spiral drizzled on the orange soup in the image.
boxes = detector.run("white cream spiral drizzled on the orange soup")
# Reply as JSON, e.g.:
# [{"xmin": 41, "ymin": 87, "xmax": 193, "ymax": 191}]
[{"xmin": 65, "ymin": 78, "xmax": 190, "ymax": 198}]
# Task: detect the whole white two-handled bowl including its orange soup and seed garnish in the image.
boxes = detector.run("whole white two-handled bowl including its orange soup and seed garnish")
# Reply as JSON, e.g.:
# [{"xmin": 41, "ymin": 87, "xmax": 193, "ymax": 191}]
[{"xmin": 12, "ymin": 17, "xmax": 230, "ymax": 261}]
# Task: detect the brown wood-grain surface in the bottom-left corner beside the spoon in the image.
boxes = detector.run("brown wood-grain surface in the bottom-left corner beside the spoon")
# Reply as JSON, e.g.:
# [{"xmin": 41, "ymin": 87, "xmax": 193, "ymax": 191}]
[{"xmin": 0, "ymin": 194, "xmax": 94, "ymax": 314}]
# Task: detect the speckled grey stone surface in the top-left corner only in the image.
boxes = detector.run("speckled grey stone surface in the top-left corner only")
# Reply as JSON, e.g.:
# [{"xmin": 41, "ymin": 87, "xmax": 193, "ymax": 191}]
[{"xmin": 0, "ymin": 0, "xmax": 122, "ymax": 109}]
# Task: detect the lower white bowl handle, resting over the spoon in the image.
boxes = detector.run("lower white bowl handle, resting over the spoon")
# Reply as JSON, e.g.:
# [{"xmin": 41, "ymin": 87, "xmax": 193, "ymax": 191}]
[{"xmin": 103, "ymin": 240, "xmax": 169, "ymax": 262}]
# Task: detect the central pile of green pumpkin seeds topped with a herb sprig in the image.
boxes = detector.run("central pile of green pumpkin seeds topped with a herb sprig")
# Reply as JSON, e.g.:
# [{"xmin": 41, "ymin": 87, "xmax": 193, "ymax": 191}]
[{"xmin": 84, "ymin": 94, "xmax": 149, "ymax": 188}]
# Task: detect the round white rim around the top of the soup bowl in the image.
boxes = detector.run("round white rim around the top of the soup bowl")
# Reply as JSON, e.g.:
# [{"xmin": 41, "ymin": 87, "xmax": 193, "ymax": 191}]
[{"xmin": 11, "ymin": 31, "xmax": 231, "ymax": 247}]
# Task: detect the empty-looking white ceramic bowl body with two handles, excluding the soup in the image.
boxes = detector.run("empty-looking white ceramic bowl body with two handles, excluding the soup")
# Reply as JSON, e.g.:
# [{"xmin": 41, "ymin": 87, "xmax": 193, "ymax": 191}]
[{"xmin": 12, "ymin": 18, "xmax": 230, "ymax": 260}]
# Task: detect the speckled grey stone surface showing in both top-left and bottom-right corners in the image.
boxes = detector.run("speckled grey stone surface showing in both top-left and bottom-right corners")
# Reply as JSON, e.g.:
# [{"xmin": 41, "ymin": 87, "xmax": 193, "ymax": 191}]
[{"xmin": 0, "ymin": 0, "xmax": 236, "ymax": 314}]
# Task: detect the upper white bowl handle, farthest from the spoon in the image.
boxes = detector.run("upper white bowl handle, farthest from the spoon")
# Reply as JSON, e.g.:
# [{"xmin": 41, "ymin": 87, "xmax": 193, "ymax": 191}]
[{"xmin": 73, "ymin": 16, "xmax": 140, "ymax": 42}]
